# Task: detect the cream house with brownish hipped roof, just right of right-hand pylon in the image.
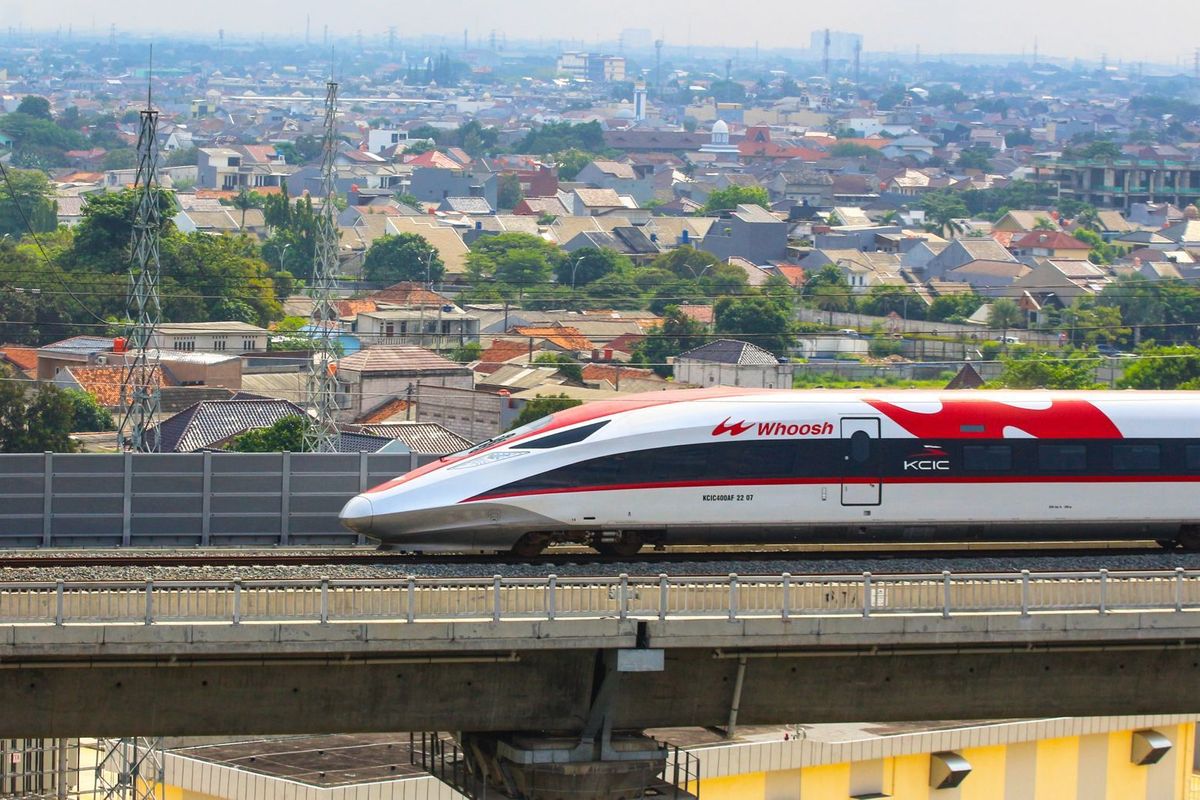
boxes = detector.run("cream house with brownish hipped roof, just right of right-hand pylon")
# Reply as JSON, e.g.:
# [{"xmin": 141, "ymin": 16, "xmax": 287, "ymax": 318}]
[{"xmin": 337, "ymin": 344, "xmax": 474, "ymax": 421}]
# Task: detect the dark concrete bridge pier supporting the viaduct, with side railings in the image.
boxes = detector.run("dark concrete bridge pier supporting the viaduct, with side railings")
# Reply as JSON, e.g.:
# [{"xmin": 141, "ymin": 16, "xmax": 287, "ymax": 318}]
[{"xmin": 421, "ymin": 648, "xmax": 698, "ymax": 800}]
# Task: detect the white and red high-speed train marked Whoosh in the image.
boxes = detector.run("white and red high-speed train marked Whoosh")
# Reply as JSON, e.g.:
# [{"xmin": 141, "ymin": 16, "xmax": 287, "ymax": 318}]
[{"xmin": 341, "ymin": 387, "xmax": 1200, "ymax": 555}]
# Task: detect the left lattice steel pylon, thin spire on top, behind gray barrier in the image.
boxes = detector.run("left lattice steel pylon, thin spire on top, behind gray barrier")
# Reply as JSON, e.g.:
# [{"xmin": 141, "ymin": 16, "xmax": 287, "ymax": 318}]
[{"xmin": 116, "ymin": 79, "xmax": 162, "ymax": 452}]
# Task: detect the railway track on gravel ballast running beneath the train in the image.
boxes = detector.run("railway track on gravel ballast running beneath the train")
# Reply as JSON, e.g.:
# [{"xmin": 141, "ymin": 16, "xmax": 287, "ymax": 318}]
[{"xmin": 0, "ymin": 541, "xmax": 1164, "ymax": 577}]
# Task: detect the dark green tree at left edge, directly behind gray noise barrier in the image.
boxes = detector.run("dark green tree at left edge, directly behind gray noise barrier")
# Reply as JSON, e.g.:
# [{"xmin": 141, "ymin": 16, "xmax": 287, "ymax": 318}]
[{"xmin": 0, "ymin": 369, "xmax": 76, "ymax": 453}]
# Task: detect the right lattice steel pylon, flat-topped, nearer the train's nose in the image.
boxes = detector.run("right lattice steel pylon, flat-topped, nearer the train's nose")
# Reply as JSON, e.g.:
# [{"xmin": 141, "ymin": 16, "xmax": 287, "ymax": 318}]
[{"xmin": 304, "ymin": 80, "xmax": 338, "ymax": 452}]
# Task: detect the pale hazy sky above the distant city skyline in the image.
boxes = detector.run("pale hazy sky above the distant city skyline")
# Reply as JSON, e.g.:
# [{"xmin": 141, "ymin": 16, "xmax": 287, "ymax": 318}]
[{"xmin": 7, "ymin": 0, "xmax": 1200, "ymax": 67}]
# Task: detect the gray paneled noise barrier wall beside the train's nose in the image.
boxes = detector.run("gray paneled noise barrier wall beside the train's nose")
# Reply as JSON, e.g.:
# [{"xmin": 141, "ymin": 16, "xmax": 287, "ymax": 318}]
[{"xmin": 0, "ymin": 452, "xmax": 436, "ymax": 548}]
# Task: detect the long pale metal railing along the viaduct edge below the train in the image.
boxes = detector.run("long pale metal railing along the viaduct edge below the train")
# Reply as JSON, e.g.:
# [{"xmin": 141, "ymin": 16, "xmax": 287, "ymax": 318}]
[{"xmin": 0, "ymin": 569, "xmax": 1200, "ymax": 625}]
